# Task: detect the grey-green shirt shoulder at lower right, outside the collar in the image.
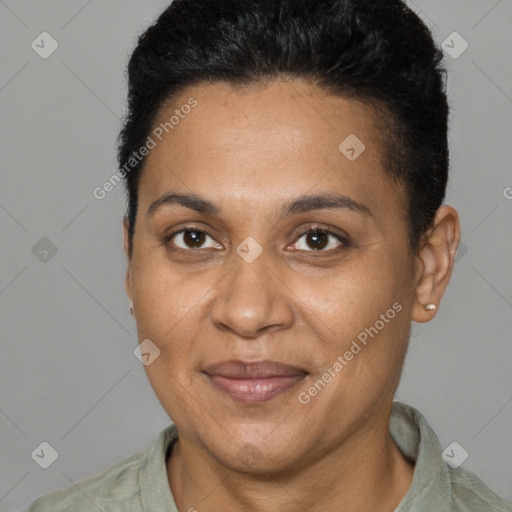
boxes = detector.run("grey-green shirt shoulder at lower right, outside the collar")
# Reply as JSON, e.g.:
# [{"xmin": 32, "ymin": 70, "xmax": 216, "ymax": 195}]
[{"xmin": 449, "ymin": 468, "xmax": 512, "ymax": 512}]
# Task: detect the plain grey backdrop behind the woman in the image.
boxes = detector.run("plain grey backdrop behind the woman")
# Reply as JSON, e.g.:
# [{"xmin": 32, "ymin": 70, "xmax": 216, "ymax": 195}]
[{"xmin": 0, "ymin": 0, "xmax": 512, "ymax": 512}]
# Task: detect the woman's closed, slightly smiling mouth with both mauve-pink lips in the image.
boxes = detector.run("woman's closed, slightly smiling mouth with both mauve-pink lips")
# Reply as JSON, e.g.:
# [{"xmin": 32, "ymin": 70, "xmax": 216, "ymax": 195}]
[{"xmin": 203, "ymin": 360, "xmax": 308, "ymax": 404}]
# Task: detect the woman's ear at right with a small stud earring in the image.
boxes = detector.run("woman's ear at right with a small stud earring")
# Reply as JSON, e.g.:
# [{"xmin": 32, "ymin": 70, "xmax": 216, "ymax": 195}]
[{"xmin": 412, "ymin": 206, "xmax": 460, "ymax": 323}]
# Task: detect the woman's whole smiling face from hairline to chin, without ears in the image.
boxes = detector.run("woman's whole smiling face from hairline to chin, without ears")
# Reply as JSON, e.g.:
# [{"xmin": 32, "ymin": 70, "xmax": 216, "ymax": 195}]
[{"xmin": 127, "ymin": 80, "xmax": 416, "ymax": 472}]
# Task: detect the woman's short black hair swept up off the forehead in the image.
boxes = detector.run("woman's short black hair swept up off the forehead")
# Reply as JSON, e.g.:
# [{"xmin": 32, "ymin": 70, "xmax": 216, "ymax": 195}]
[{"xmin": 118, "ymin": 0, "xmax": 449, "ymax": 254}]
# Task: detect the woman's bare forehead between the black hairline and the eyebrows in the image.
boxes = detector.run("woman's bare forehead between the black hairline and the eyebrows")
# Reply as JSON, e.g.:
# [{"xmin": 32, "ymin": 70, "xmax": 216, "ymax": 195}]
[{"xmin": 139, "ymin": 80, "xmax": 403, "ymax": 221}]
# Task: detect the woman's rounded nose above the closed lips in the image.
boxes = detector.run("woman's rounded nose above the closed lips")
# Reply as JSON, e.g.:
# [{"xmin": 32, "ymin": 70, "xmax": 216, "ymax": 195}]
[{"xmin": 211, "ymin": 253, "xmax": 294, "ymax": 338}]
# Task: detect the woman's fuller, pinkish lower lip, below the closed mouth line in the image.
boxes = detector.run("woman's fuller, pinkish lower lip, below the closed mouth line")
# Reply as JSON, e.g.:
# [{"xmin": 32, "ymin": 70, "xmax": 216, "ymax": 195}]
[{"xmin": 206, "ymin": 373, "xmax": 306, "ymax": 403}]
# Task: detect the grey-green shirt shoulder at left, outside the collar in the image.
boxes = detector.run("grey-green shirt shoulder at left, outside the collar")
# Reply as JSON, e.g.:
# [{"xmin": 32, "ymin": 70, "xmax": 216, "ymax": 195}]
[{"xmin": 19, "ymin": 452, "xmax": 145, "ymax": 512}]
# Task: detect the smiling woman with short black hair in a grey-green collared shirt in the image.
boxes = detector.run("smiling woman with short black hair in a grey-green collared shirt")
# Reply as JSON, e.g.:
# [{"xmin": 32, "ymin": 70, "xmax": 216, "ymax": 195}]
[{"xmin": 22, "ymin": 0, "xmax": 512, "ymax": 512}]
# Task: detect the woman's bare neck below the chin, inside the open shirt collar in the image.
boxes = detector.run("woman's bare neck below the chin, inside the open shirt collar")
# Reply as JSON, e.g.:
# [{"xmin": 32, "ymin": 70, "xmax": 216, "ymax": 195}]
[{"xmin": 167, "ymin": 406, "xmax": 414, "ymax": 512}]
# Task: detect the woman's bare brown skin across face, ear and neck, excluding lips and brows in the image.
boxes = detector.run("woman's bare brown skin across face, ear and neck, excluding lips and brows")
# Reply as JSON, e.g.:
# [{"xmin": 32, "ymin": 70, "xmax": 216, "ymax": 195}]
[{"xmin": 124, "ymin": 80, "xmax": 460, "ymax": 512}]
